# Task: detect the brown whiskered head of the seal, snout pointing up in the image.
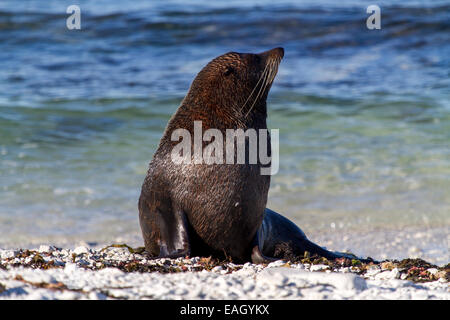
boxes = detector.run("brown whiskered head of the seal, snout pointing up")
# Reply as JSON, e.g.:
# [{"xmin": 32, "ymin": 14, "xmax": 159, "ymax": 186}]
[{"xmin": 181, "ymin": 48, "xmax": 284, "ymax": 121}]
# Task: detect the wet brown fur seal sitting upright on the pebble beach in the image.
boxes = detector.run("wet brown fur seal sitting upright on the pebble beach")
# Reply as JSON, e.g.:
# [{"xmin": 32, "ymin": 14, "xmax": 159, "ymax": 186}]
[{"xmin": 138, "ymin": 48, "xmax": 370, "ymax": 263}]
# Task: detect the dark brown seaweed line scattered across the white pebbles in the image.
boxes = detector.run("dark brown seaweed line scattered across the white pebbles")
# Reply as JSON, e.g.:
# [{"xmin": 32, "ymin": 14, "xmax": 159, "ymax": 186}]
[{"xmin": 0, "ymin": 243, "xmax": 450, "ymax": 289}]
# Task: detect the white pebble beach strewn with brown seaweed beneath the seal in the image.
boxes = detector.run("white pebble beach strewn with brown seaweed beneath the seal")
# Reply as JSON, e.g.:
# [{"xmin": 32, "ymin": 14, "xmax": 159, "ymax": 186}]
[{"xmin": 0, "ymin": 244, "xmax": 450, "ymax": 300}]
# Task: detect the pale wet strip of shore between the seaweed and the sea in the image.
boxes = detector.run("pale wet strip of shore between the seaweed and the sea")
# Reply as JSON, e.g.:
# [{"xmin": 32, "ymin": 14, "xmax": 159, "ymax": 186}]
[{"xmin": 0, "ymin": 220, "xmax": 450, "ymax": 266}]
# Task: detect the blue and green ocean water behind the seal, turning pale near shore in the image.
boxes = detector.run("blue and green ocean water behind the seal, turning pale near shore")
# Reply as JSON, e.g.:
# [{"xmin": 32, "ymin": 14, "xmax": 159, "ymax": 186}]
[{"xmin": 0, "ymin": 0, "xmax": 450, "ymax": 262}]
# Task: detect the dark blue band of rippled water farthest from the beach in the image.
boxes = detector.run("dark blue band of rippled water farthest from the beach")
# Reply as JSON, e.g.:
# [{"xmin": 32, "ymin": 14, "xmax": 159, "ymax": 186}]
[{"xmin": 0, "ymin": 5, "xmax": 450, "ymax": 52}]
